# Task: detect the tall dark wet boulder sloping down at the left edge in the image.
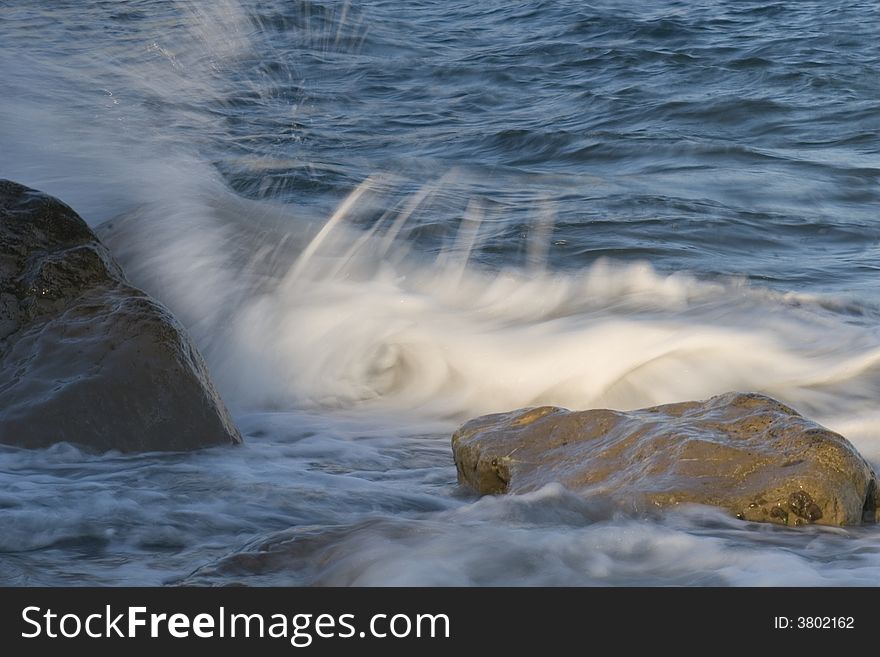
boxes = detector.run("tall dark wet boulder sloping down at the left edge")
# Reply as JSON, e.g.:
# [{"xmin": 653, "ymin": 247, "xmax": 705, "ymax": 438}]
[{"xmin": 0, "ymin": 181, "xmax": 241, "ymax": 452}]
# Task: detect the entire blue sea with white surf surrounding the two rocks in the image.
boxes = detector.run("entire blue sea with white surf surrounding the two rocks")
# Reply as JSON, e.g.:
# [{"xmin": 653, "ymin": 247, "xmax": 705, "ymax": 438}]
[{"xmin": 0, "ymin": 0, "xmax": 880, "ymax": 586}]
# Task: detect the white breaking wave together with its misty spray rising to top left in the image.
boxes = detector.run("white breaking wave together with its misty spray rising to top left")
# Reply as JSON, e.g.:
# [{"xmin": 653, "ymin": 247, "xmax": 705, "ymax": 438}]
[{"xmin": 0, "ymin": 0, "xmax": 880, "ymax": 462}]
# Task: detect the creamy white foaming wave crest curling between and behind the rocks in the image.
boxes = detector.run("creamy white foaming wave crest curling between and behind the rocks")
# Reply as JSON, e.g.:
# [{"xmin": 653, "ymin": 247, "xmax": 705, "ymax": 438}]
[{"xmin": 96, "ymin": 174, "xmax": 880, "ymax": 458}]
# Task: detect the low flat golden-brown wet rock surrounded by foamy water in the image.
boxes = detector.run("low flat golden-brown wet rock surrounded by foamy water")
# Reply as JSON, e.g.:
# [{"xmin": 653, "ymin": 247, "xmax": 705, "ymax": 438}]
[{"xmin": 452, "ymin": 393, "xmax": 880, "ymax": 525}]
